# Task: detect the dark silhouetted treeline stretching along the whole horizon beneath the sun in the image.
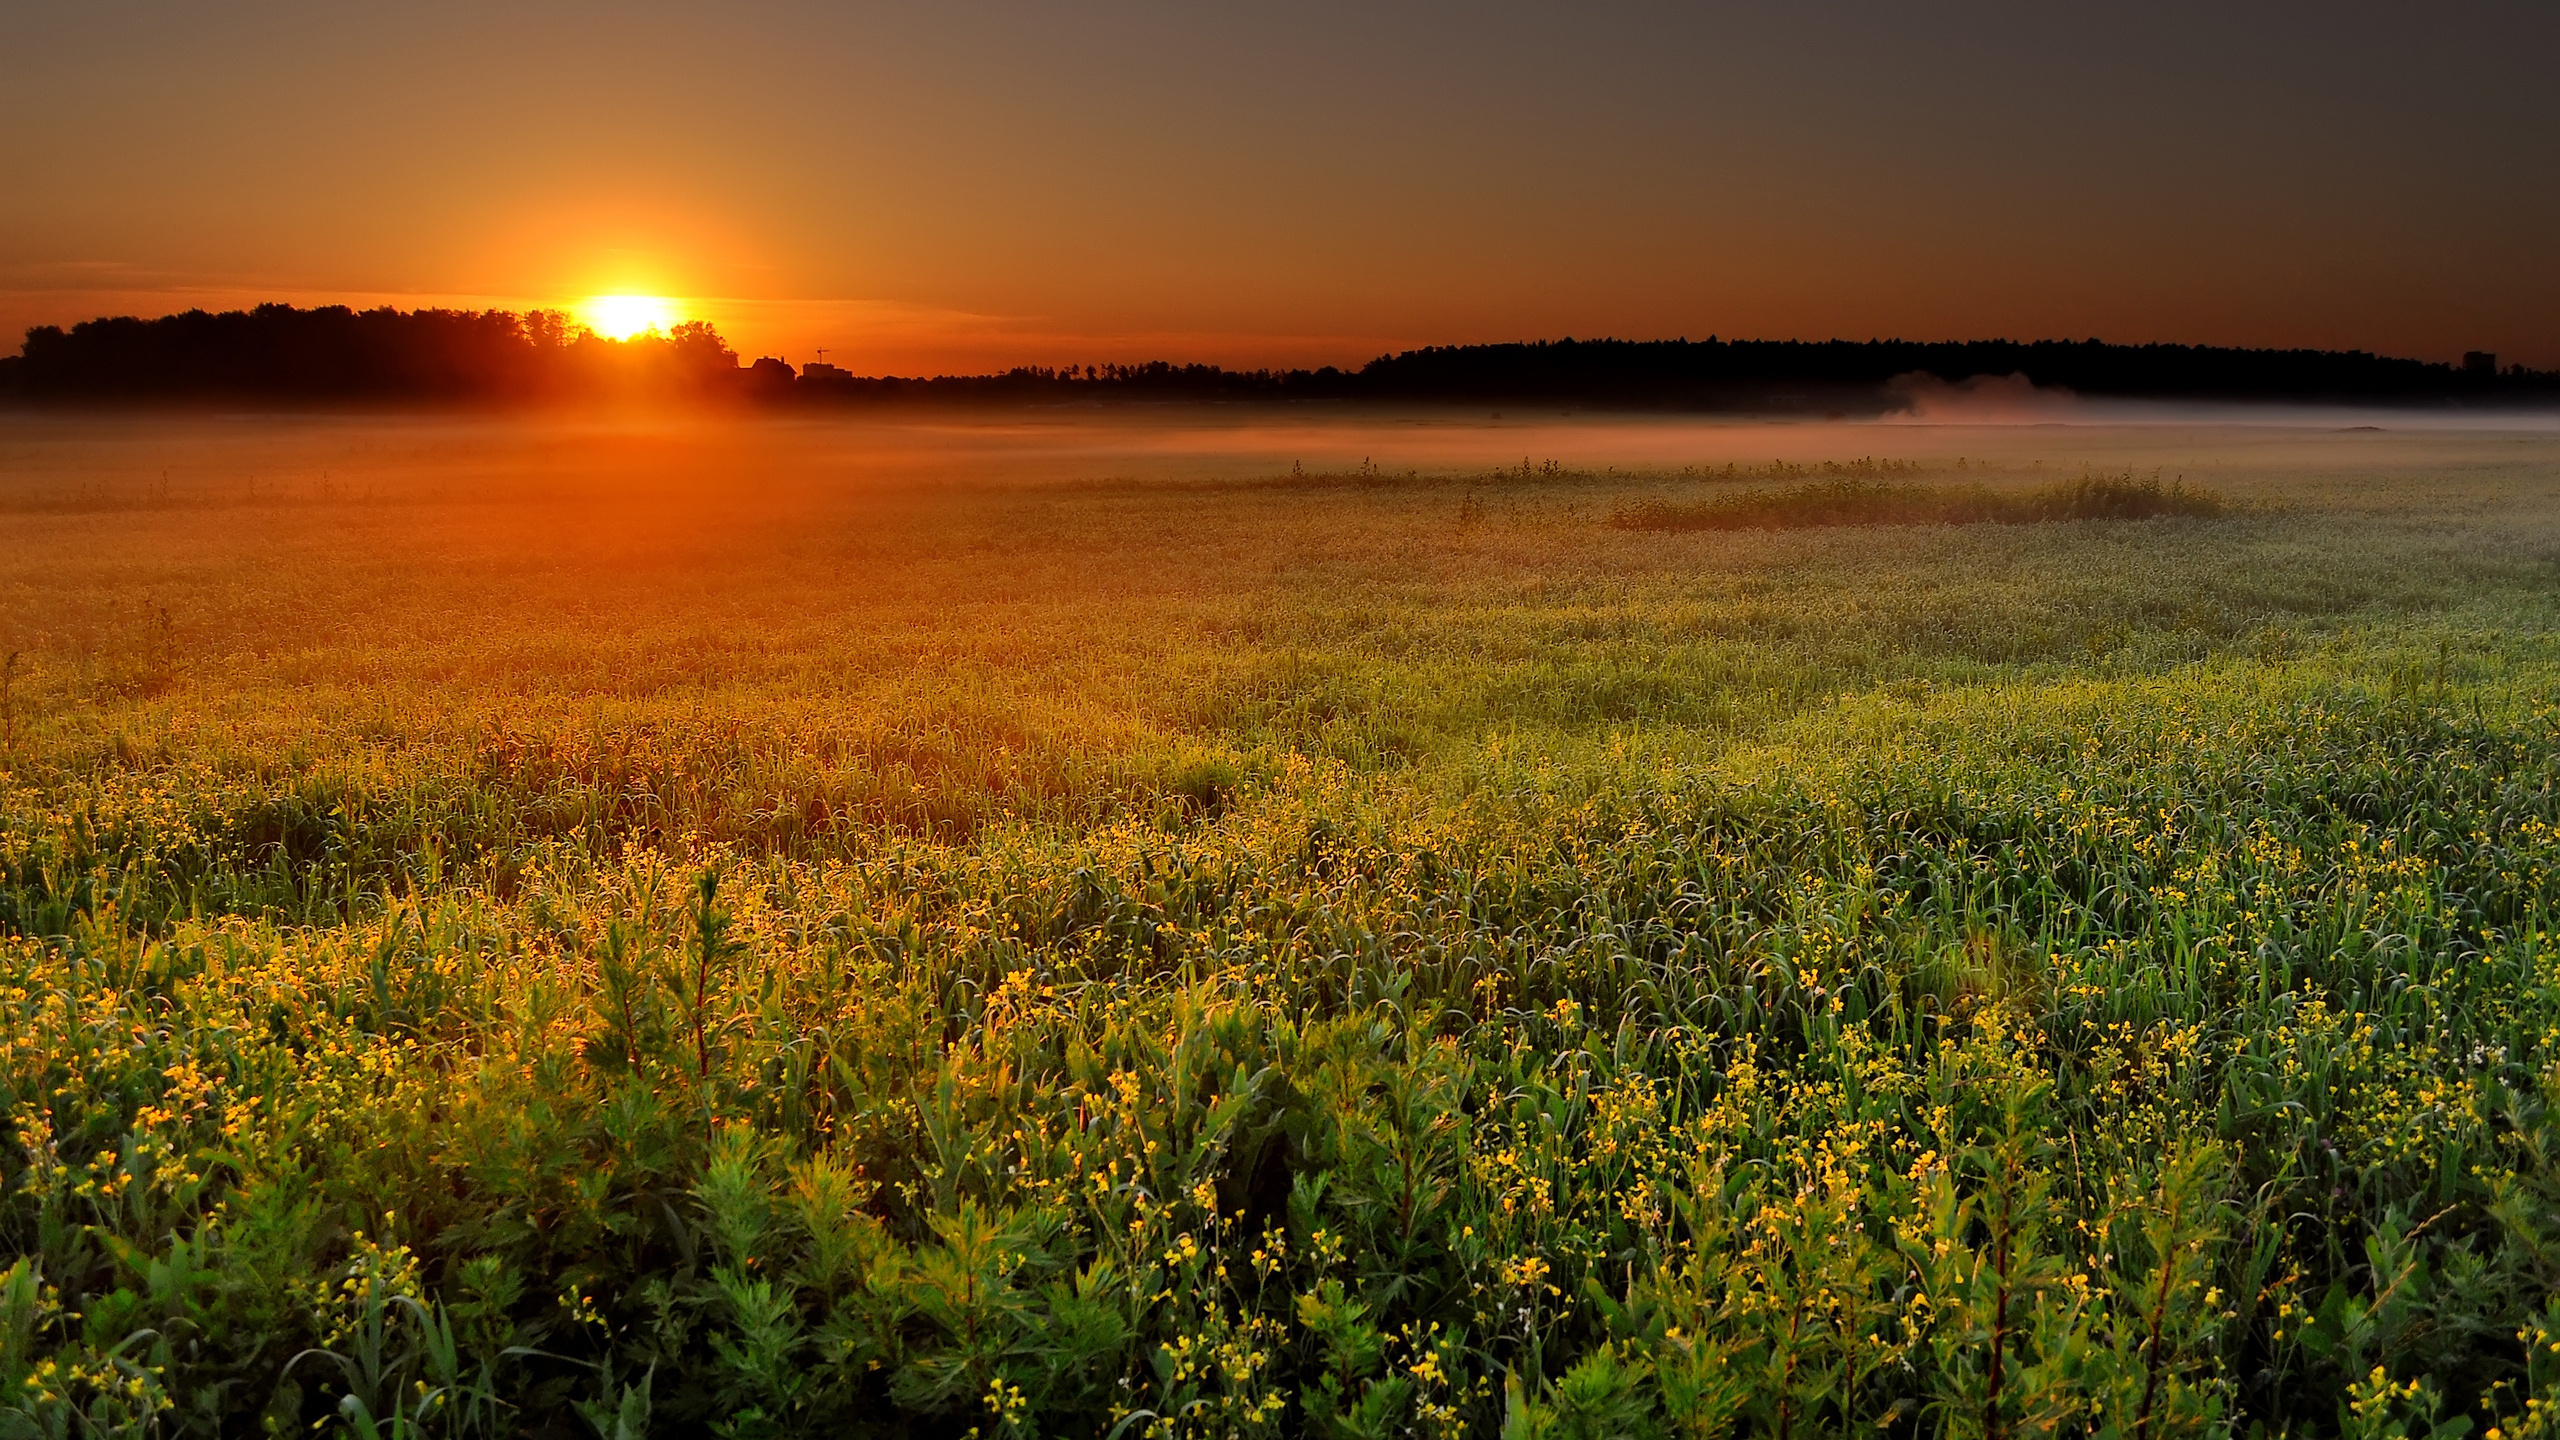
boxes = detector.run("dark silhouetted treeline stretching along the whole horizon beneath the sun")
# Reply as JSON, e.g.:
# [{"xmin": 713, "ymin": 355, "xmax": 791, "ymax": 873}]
[{"xmin": 0, "ymin": 305, "xmax": 2560, "ymax": 410}]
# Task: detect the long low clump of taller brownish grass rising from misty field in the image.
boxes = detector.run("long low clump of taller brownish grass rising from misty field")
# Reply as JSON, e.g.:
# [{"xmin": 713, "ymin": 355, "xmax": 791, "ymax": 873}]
[{"xmin": 1610, "ymin": 474, "xmax": 2230, "ymax": 530}]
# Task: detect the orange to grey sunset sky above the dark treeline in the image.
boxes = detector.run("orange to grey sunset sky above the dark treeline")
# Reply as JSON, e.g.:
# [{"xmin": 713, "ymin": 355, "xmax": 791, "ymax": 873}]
[{"xmin": 0, "ymin": 0, "xmax": 2560, "ymax": 374}]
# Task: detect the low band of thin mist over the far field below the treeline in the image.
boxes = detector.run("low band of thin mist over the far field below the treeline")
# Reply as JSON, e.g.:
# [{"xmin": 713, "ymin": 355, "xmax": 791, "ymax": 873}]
[{"xmin": 0, "ymin": 394, "xmax": 2560, "ymax": 507}]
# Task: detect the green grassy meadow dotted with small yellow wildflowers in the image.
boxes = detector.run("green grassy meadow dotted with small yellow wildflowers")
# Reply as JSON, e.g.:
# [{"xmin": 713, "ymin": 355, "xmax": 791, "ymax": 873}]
[{"xmin": 0, "ymin": 415, "xmax": 2560, "ymax": 1440}]
